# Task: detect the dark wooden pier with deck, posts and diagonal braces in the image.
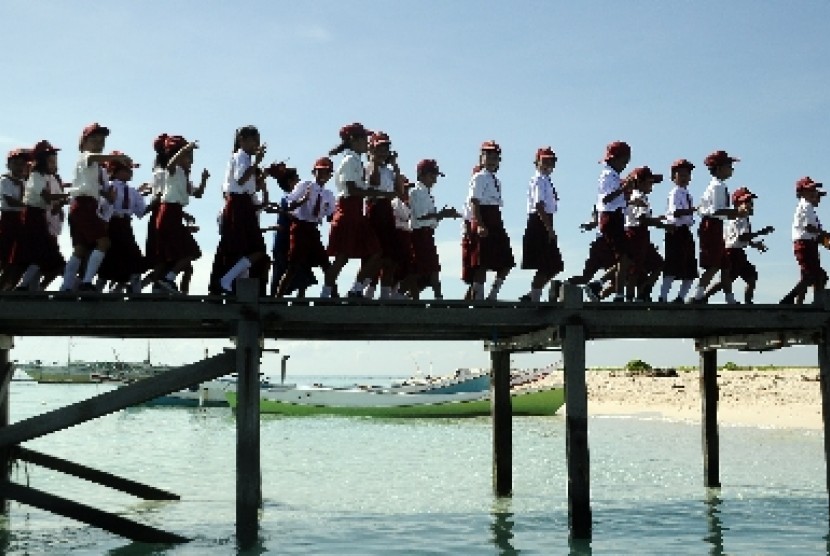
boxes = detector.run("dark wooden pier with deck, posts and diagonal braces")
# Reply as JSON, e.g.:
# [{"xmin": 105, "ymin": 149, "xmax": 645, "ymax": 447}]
[{"xmin": 0, "ymin": 280, "xmax": 830, "ymax": 549}]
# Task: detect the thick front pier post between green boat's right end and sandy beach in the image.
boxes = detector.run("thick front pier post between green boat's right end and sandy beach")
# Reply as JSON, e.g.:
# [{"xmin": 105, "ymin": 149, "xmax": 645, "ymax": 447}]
[{"xmin": 562, "ymin": 285, "xmax": 591, "ymax": 539}]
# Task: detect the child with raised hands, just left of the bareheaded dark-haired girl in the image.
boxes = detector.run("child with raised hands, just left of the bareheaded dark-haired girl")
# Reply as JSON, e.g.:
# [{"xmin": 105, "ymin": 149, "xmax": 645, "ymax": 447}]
[{"xmin": 156, "ymin": 135, "xmax": 210, "ymax": 293}]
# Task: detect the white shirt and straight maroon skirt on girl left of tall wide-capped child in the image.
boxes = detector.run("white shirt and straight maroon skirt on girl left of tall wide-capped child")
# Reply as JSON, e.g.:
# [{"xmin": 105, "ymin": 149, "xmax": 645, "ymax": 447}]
[{"xmin": 663, "ymin": 186, "xmax": 698, "ymax": 280}]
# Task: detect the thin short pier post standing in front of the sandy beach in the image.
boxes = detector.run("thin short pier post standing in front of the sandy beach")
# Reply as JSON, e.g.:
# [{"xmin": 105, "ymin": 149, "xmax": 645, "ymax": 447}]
[{"xmin": 700, "ymin": 349, "xmax": 720, "ymax": 488}]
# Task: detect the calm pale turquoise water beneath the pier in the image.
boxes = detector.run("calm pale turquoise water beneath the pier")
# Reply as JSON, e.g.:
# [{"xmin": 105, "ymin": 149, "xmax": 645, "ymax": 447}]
[{"xmin": 0, "ymin": 378, "xmax": 830, "ymax": 556}]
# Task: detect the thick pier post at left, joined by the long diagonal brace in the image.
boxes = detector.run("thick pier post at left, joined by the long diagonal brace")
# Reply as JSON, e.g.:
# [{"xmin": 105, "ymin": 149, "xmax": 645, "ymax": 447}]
[{"xmin": 236, "ymin": 279, "xmax": 262, "ymax": 550}]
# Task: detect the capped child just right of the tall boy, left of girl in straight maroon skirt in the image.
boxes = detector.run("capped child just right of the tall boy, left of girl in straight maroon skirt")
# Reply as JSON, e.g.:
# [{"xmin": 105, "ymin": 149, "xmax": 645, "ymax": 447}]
[{"xmin": 625, "ymin": 166, "xmax": 665, "ymax": 301}]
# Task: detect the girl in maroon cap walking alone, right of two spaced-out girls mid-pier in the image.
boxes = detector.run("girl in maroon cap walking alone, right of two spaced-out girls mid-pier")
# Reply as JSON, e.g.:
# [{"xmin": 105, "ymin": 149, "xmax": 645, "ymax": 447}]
[{"xmin": 519, "ymin": 147, "xmax": 565, "ymax": 303}]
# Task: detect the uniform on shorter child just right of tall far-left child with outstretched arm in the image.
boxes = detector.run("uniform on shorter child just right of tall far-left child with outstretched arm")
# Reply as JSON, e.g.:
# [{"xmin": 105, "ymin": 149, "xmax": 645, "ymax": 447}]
[{"xmin": 98, "ymin": 180, "xmax": 148, "ymax": 283}]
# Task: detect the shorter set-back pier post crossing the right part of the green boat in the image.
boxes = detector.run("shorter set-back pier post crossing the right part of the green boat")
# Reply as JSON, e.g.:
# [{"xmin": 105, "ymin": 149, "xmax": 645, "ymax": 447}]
[{"xmin": 490, "ymin": 350, "xmax": 513, "ymax": 496}]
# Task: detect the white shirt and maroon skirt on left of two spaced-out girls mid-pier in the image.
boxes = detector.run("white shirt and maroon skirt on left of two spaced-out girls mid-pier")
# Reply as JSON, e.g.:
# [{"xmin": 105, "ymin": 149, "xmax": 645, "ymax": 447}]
[{"xmin": 469, "ymin": 169, "xmax": 516, "ymax": 271}]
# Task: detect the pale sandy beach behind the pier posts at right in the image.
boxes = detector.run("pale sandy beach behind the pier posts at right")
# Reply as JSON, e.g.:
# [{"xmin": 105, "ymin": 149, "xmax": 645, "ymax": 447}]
[{"xmin": 548, "ymin": 368, "xmax": 822, "ymax": 430}]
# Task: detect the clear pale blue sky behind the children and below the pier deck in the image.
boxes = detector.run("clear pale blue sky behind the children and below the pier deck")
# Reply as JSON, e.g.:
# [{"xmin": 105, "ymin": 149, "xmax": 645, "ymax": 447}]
[{"xmin": 0, "ymin": 0, "xmax": 830, "ymax": 375}]
